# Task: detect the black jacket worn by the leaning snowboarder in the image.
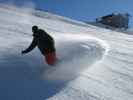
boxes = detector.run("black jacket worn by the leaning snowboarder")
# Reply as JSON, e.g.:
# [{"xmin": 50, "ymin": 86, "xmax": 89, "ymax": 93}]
[{"xmin": 25, "ymin": 29, "xmax": 55, "ymax": 55}]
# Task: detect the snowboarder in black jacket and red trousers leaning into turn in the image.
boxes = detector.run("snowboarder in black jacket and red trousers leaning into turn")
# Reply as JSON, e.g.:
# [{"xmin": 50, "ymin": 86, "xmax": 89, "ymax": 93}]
[{"xmin": 22, "ymin": 26, "xmax": 57, "ymax": 65}]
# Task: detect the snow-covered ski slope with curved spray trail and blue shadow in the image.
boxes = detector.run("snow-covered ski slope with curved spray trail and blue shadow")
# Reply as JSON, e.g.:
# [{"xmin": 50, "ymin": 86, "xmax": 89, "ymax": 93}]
[{"xmin": 0, "ymin": 5, "xmax": 133, "ymax": 100}]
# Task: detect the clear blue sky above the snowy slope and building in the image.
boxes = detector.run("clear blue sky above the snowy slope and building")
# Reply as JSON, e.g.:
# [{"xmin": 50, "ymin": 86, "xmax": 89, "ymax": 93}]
[{"xmin": 0, "ymin": 0, "xmax": 133, "ymax": 26}]
